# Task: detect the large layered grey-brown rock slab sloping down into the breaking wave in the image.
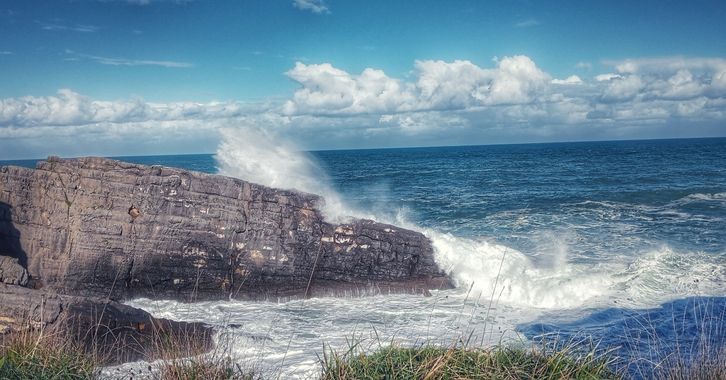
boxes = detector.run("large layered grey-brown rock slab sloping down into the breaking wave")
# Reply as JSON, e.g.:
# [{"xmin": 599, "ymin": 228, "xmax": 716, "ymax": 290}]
[{"xmin": 0, "ymin": 158, "xmax": 451, "ymax": 301}]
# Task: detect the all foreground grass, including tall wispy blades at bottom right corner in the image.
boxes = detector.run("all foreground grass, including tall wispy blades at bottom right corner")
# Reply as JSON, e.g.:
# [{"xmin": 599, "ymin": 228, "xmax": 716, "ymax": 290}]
[{"xmin": 0, "ymin": 296, "xmax": 726, "ymax": 380}]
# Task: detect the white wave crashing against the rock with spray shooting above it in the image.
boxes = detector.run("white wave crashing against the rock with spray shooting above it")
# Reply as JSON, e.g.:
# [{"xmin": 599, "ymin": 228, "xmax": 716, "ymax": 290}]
[{"xmin": 216, "ymin": 128, "xmax": 726, "ymax": 309}]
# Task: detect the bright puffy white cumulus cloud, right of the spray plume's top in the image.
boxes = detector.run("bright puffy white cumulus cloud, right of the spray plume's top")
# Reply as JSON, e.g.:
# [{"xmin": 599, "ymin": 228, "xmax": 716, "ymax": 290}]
[{"xmin": 283, "ymin": 56, "xmax": 550, "ymax": 115}]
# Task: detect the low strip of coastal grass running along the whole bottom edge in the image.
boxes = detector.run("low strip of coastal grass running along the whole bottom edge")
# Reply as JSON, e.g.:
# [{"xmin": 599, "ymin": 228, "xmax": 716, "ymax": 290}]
[{"xmin": 0, "ymin": 330, "xmax": 726, "ymax": 380}]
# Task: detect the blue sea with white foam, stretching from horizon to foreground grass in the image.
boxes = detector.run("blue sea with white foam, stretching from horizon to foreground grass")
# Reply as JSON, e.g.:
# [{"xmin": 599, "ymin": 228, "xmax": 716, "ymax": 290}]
[{"xmin": 2, "ymin": 138, "xmax": 726, "ymax": 378}]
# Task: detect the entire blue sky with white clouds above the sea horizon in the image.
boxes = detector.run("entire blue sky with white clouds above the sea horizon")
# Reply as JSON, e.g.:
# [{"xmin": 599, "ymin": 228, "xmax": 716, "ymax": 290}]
[{"xmin": 0, "ymin": 0, "xmax": 726, "ymax": 160}]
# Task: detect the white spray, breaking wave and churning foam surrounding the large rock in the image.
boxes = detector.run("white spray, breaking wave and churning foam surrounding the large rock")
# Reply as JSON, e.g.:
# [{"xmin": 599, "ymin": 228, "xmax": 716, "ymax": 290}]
[{"xmin": 102, "ymin": 130, "xmax": 726, "ymax": 378}]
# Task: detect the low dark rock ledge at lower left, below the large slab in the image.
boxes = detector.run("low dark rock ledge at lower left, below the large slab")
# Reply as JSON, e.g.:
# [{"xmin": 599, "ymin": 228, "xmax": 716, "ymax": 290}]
[{"xmin": 0, "ymin": 283, "xmax": 212, "ymax": 364}]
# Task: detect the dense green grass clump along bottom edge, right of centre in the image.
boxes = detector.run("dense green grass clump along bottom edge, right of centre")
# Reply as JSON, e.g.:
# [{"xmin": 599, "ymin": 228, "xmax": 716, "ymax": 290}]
[{"xmin": 321, "ymin": 345, "xmax": 621, "ymax": 380}]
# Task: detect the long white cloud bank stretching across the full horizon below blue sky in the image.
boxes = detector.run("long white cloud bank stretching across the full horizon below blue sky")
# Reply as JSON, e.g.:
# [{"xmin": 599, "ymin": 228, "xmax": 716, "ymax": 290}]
[{"xmin": 0, "ymin": 55, "xmax": 726, "ymax": 158}]
